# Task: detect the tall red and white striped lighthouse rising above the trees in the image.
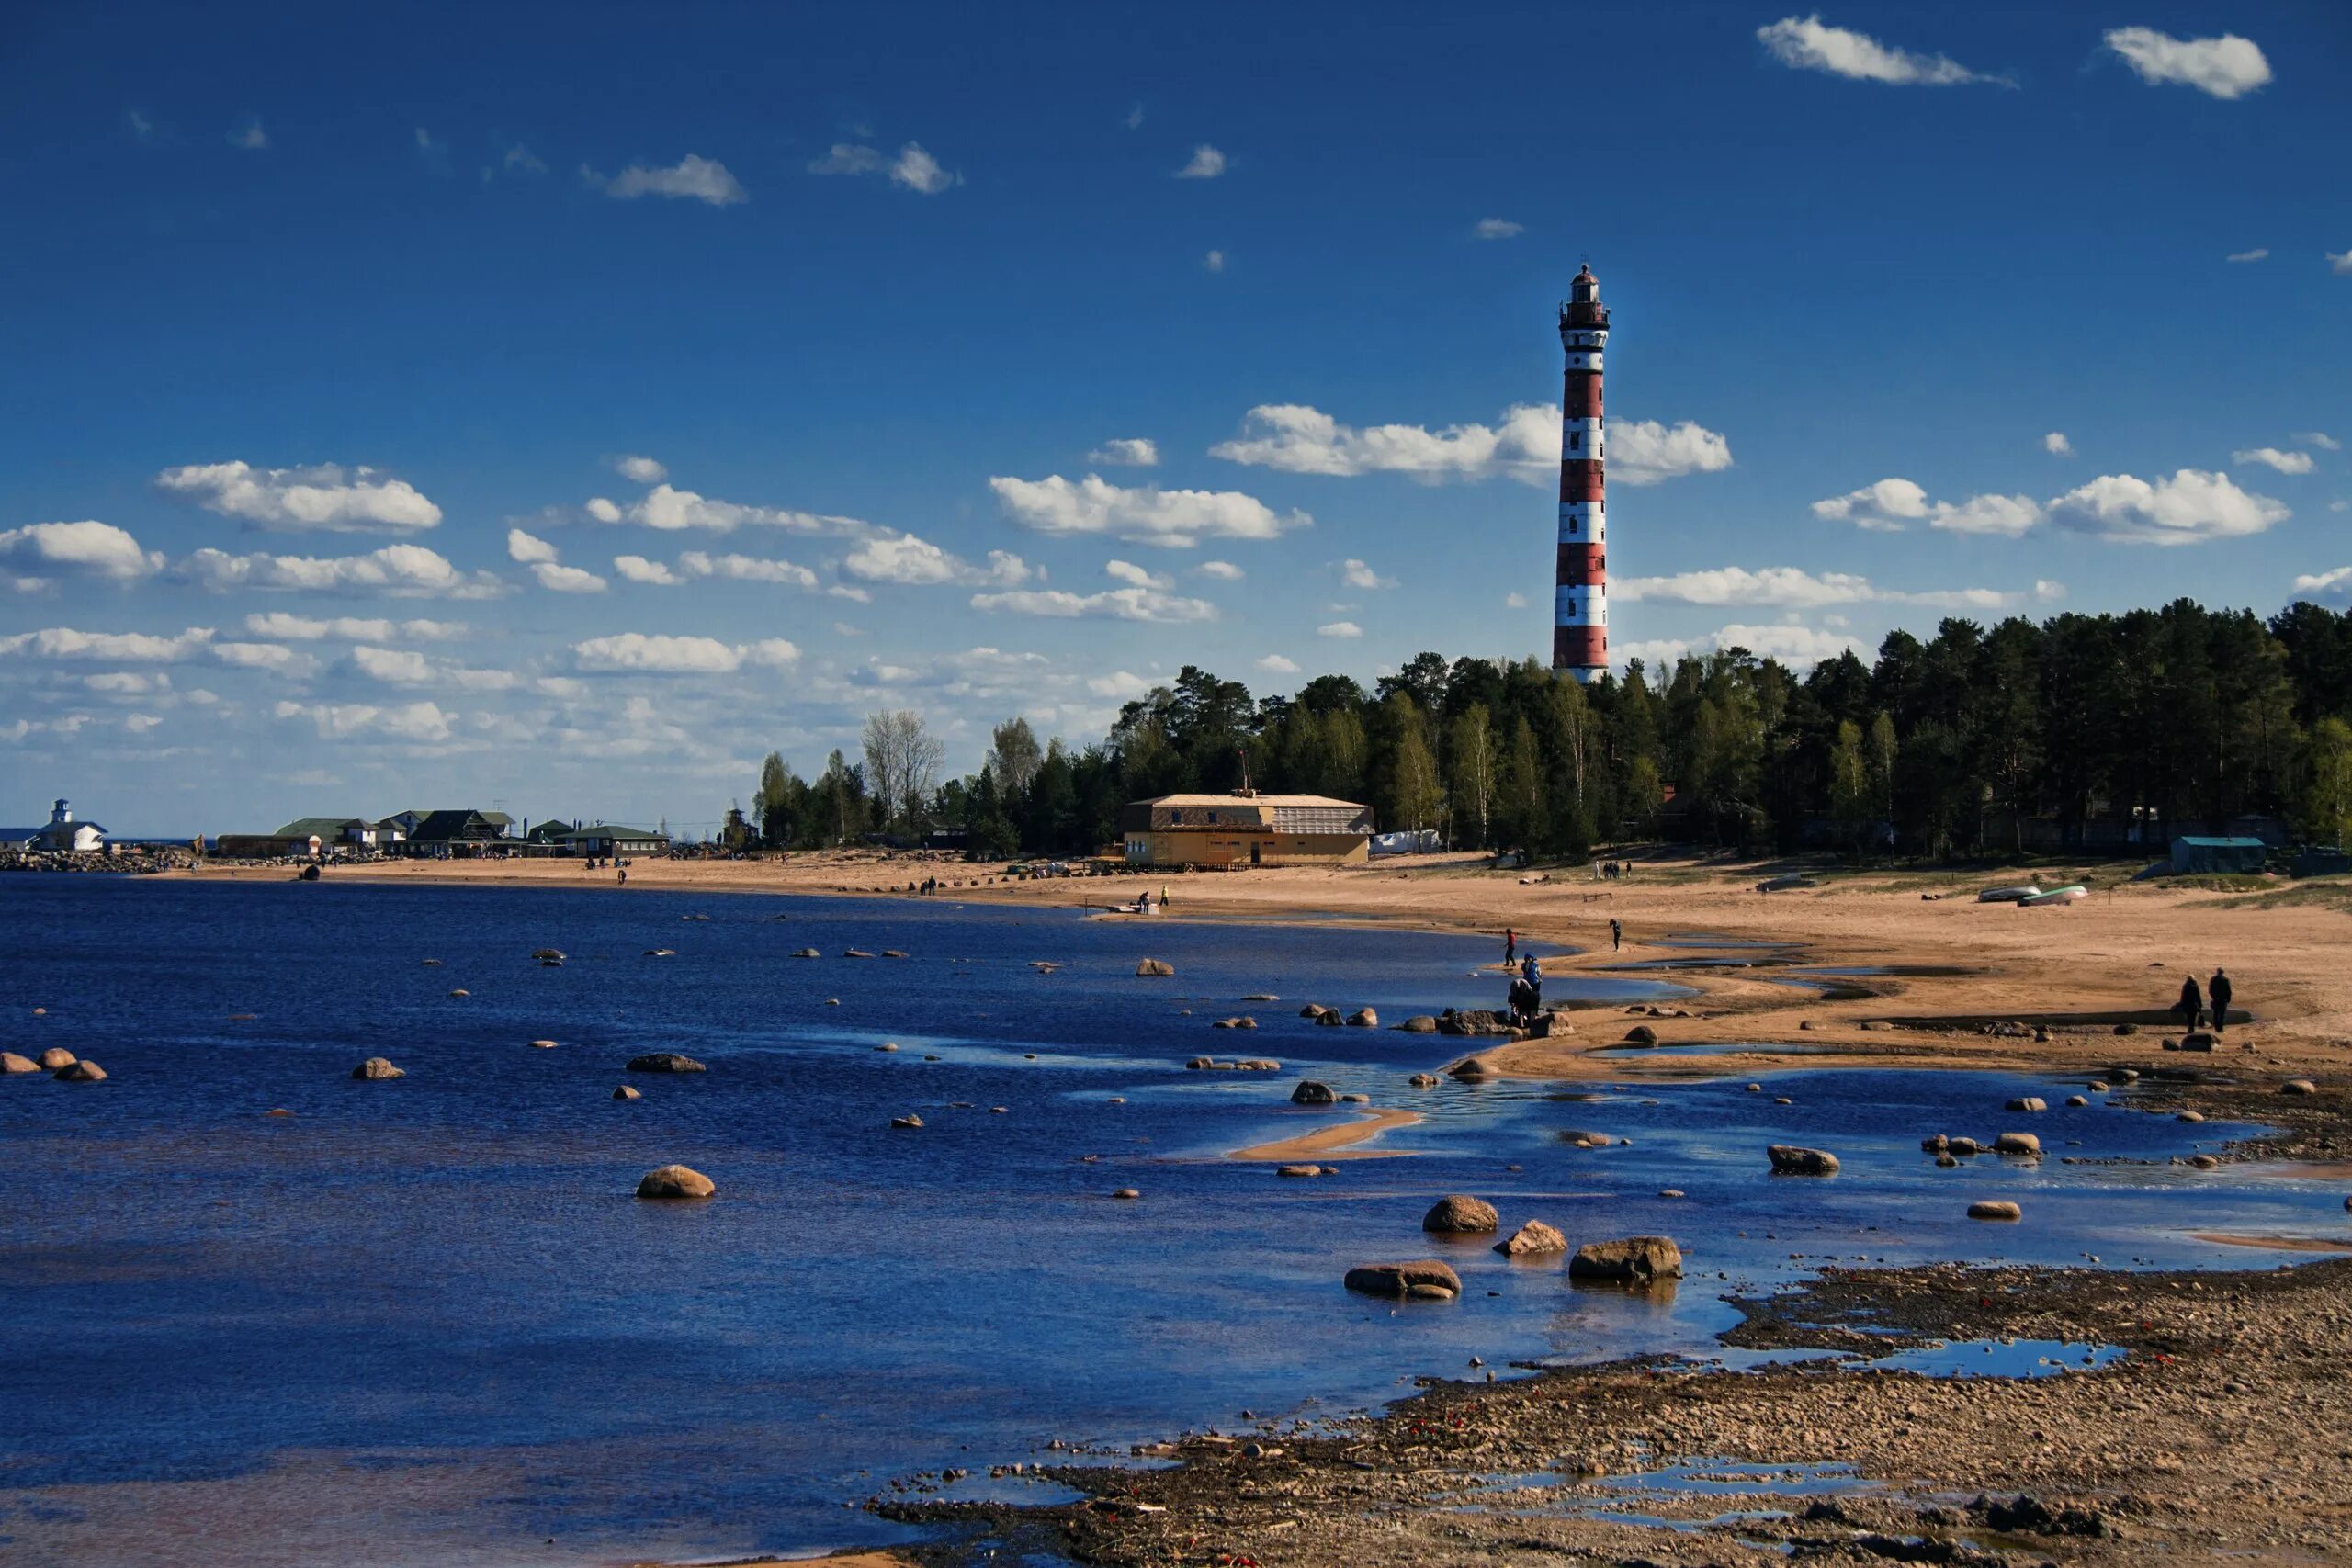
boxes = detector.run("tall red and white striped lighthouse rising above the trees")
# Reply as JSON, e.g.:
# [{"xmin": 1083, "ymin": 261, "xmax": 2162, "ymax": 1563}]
[{"xmin": 1553, "ymin": 265, "xmax": 1609, "ymax": 684}]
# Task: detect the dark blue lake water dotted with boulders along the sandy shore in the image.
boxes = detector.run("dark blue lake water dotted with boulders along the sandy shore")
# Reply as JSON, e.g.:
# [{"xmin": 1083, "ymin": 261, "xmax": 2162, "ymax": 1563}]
[{"xmin": 0, "ymin": 877, "xmax": 2345, "ymax": 1568}]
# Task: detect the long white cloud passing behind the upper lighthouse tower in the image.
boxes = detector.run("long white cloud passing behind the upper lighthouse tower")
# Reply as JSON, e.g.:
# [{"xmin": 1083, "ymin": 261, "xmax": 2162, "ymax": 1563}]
[{"xmin": 1209, "ymin": 402, "xmax": 1731, "ymax": 484}]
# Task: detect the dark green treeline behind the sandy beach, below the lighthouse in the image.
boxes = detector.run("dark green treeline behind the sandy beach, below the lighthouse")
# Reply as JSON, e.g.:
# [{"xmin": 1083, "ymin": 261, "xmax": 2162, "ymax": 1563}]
[{"xmin": 733, "ymin": 600, "xmax": 2352, "ymax": 858}]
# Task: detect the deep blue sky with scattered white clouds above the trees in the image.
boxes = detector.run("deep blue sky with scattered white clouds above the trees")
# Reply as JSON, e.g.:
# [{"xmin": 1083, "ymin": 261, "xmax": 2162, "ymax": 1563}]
[{"xmin": 0, "ymin": 3, "xmax": 2352, "ymax": 832}]
